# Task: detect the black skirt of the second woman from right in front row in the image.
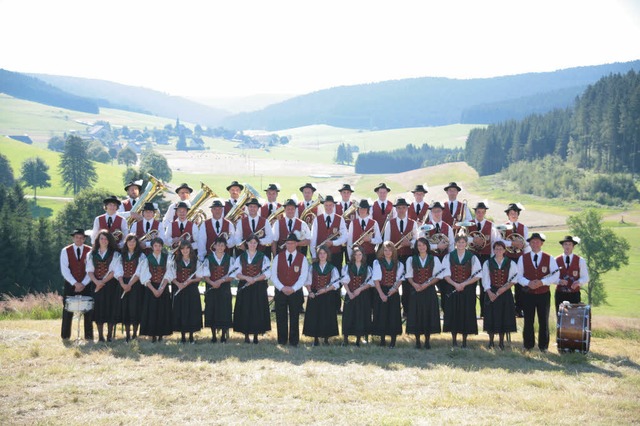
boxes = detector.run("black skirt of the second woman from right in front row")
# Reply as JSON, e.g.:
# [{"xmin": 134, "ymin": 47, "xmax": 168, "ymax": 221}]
[{"xmin": 442, "ymin": 284, "xmax": 478, "ymax": 334}]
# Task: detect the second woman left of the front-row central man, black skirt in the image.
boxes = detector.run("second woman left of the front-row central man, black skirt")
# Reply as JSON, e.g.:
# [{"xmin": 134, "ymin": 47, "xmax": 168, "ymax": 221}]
[{"xmin": 200, "ymin": 237, "xmax": 233, "ymax": 343}]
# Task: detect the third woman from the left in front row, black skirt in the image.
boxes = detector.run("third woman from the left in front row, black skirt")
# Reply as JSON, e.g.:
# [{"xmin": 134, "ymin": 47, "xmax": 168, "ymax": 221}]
[{"xmin": 140, "ymin": 238, "xmax": 173, "ymax": 343}]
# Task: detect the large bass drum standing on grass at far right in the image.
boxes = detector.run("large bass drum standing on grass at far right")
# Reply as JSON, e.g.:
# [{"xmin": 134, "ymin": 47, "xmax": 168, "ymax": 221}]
[{"xmin": 556, "ymin": 301, "xmax": 591, "ymax": 354}]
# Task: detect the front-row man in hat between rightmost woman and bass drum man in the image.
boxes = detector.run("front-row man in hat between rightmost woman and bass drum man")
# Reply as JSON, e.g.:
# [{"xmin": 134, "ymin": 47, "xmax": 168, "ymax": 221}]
[{"xmin": 516, "ymin": 232, "xmax": 560, "ymax": 352}]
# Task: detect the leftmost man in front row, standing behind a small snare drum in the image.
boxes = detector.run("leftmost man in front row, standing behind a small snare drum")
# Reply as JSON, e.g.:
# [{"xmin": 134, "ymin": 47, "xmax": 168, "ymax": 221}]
[{"xmin": 60, "ymin": 228, "xmax": 93, "ymax": 340}]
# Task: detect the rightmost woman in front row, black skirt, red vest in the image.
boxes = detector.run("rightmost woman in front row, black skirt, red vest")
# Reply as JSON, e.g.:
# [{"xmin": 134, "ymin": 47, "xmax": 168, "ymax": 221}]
[{"xmin": 482, "ymin": 241, "xmax": 518, "ymax": 349}]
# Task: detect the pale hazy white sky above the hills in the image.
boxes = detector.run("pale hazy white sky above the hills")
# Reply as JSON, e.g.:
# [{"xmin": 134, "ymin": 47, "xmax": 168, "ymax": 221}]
[{"xmin": 0, "ymin": 0, "xmax": 640, "ymax": 97}]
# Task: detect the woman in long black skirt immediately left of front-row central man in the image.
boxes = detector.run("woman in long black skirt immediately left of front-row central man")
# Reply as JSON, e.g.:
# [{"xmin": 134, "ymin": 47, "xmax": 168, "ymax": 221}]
[{"xmin": 233, "ymin": 234, "xmax": 271, "ymax": 344}]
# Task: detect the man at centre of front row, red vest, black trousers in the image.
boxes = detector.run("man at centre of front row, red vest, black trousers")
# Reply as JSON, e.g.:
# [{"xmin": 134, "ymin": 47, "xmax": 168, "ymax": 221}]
[{"xmin": 271, "ymin": 233, "xmax": 309, "ymax": 346}]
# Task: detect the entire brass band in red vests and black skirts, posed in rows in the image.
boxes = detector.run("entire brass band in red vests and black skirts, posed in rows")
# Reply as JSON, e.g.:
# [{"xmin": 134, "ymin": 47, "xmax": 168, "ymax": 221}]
[{"xmin": 60, "ymin": 177, "xmax": 589, "ymax": 351}]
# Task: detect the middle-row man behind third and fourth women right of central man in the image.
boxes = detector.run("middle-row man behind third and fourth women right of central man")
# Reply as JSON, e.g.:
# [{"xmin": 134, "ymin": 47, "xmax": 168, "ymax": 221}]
[{"xmin": 383, "ymin": 197, "xmax": 418, "ymax": 317}]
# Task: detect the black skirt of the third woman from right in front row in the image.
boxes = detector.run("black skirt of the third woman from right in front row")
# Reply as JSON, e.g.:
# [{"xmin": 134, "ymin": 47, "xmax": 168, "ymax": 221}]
[{"xmin": 407, "ymin": 285, "xmax": 440, "ymax": 335}]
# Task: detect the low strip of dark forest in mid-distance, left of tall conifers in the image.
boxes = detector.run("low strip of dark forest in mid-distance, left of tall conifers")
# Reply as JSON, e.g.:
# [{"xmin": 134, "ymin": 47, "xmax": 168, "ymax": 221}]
[{"xmin": 355, "ymin": 143, "xmax": 464, "ymax": 174}]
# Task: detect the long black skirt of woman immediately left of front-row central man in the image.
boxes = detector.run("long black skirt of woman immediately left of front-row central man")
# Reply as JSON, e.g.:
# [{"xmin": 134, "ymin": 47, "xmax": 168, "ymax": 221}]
[{"xmin": 233, "ymin": 281, "xmax": 271, "ymax": 334}]
